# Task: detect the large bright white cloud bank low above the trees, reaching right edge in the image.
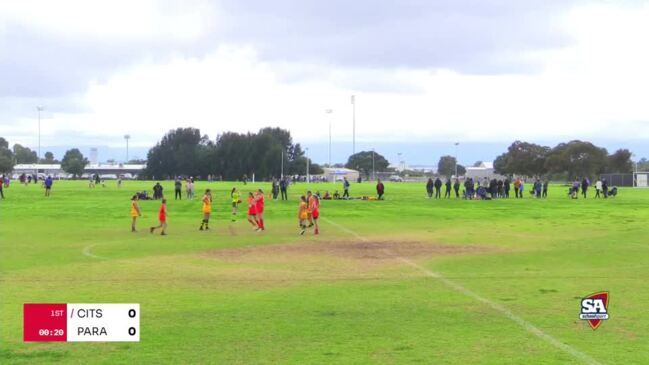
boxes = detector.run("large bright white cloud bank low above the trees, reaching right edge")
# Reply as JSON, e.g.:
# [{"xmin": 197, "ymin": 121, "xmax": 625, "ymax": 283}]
[{"xmin": 3, "ymin": 2, "xmax": 649, "ymax": 149}]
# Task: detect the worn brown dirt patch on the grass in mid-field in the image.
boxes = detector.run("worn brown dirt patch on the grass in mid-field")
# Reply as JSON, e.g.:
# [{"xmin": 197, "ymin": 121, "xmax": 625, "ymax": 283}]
[{"xmin": 195, "ymin": 240, "xmax": 497, "ymax": 288}]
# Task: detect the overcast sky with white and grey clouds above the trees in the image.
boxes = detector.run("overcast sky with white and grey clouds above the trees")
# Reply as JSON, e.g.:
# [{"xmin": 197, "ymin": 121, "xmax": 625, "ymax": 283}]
[{"xmin": 0, "ymin": 0, "xmax": 649, "ymax": 161}]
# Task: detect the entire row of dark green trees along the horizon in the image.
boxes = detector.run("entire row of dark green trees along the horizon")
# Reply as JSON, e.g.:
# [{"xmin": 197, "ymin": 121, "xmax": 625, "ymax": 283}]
[{"xmin": 0, "ymin": 134, "xmax": 636, "ymax": 180}]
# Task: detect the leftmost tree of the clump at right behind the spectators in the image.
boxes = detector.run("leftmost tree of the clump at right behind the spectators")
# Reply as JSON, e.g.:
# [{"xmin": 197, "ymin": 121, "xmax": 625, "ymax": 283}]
[{"xmin": 494, "ymin": 141, "xmax": 550, "ymax": 176}]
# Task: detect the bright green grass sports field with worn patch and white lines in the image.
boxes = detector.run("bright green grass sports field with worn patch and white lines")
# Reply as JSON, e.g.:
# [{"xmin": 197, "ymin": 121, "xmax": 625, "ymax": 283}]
[{"xmin": 0, "ymin": 181, "xmax": 649, "ymax": 364}]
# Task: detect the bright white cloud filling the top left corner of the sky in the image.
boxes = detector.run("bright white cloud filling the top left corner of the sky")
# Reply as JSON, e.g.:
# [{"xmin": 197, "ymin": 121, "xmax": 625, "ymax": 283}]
[{"xmin": 0, "ymin": 0, "xmax": 213, "ymax": 41}]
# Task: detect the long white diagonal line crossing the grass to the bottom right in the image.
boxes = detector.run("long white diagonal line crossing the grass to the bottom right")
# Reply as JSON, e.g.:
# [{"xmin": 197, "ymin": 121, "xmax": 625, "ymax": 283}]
[{"xmin": 322, "ymin": 217, "xmax": 600, "ymax": 365}]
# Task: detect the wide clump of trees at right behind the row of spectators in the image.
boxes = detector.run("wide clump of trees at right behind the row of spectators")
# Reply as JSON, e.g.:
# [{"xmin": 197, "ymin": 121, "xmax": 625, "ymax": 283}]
[{"xmin": 494, "ymin": 140, "xmax": 633, "ymax": 179}]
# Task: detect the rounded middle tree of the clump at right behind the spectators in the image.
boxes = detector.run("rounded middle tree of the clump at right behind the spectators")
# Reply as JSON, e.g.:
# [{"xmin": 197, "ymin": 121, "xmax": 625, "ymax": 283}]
[{"xmin": 546, "ymin": 140, "xmax": 608, "ymax": 179}]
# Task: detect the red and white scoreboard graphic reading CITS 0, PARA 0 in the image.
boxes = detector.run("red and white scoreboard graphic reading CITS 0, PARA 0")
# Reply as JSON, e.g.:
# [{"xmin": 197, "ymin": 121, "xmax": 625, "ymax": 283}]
[{"xmin": 23, "ymin": 303, "xmax": 140, "ymax": 342}]
